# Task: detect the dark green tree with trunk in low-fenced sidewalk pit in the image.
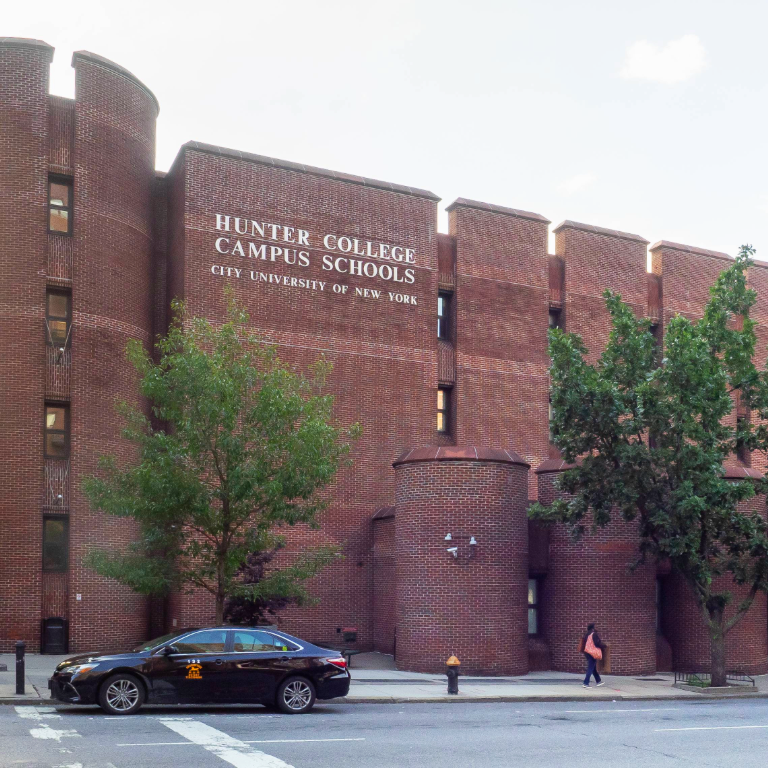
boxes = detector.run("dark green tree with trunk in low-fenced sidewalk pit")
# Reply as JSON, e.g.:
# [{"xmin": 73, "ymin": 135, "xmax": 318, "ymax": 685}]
[{"xmin": 530, "ymin": 246, "xmax": 768, "ymax": 685}]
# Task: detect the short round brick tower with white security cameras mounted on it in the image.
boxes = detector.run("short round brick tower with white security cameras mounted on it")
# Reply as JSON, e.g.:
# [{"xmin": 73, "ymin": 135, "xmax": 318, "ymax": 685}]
[{"xmin": 394, "ymin": 446, "xmax": 529, "ymax": 675}]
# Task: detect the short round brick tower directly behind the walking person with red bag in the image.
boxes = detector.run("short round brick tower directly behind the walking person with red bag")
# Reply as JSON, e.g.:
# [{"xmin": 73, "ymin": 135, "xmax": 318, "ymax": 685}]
[{"xmin": 536, "ymin": 459, "xmax": 656, "ymax": 675}]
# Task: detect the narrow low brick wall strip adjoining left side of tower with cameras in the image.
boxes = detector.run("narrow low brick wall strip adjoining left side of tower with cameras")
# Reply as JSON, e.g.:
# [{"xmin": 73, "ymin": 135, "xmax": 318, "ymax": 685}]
[{"xmin": 373, "ymin": 510, "xmax": 397, "ymax": 653}]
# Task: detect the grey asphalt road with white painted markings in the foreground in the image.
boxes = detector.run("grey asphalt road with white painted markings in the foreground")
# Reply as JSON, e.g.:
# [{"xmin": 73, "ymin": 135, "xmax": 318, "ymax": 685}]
[{"xmin": 0, "ymin": 699, "xmax": 768, "ymax": 768}]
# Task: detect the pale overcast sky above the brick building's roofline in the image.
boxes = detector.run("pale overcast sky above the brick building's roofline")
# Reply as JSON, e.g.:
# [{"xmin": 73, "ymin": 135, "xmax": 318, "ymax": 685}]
[{"xmin": 6, "ymin": 0, "xmax": 768, "ymax": 260}]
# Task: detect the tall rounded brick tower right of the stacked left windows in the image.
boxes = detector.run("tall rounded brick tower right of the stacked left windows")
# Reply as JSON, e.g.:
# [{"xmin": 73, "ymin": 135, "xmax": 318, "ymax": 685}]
[{"xmin": 70, "ymin": 51, "xmax": 159, "ymax": 651}]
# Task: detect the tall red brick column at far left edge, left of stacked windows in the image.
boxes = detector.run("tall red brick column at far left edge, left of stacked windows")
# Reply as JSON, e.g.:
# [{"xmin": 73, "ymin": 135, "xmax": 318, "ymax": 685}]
[{"xmin": 0, "ymin": 41, "xmax": 53, "ymax": 652}]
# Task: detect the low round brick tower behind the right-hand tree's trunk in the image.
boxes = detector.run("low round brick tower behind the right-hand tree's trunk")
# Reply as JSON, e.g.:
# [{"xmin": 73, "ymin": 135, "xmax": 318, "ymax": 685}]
[{"xmin": 661, "ymin": 465, "xmax": 768, "ymax": 675}]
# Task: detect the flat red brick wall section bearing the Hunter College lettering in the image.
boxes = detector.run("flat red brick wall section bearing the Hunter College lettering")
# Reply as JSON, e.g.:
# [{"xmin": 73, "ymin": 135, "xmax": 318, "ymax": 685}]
[{"xmin": 169, "ymin": 146, "xmax": 437, "ymax": 648}]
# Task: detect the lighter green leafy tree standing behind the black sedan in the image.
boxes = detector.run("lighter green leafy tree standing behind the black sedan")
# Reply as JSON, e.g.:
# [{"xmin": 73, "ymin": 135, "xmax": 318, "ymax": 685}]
[{"xmin": 83, "ymin": 297, "xmax": 360, "ymax": 623}]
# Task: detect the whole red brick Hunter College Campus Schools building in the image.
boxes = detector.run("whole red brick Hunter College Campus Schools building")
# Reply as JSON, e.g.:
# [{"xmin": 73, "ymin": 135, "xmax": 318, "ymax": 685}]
[{"xmin": 0, "ymin": 38, "xmax": 768, "ymax": 674}]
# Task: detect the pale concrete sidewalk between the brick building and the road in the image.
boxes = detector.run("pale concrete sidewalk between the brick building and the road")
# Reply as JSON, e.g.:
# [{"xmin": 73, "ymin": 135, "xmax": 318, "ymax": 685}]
[{"xmin": 0, "ymin": 653, "xmax": 768, "ymax": 704}]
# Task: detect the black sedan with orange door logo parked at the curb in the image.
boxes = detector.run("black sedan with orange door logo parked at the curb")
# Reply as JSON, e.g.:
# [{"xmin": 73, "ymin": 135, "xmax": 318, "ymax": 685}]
[{"xmin": 48, "ymin": 627, "xmax": 350, "ymax": 715}]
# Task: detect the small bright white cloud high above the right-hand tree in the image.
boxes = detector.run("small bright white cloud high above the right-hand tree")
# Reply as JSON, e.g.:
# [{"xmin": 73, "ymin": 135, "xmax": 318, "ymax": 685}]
[{"xmin": 619, "ymin": 35, "xmax": 707, "ymax": 85}]
